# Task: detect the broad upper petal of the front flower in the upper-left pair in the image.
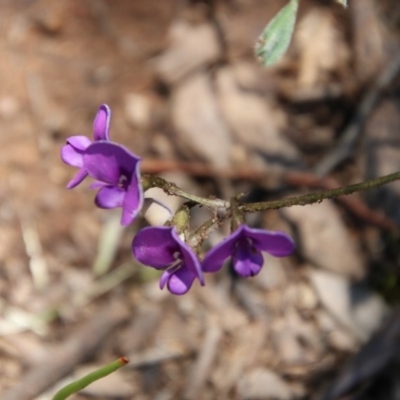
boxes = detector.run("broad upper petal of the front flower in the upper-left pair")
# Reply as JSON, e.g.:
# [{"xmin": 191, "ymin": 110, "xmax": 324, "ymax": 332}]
[{"xmin": 83, "ymin": 140, "xmax": 140, "ymax": 185}]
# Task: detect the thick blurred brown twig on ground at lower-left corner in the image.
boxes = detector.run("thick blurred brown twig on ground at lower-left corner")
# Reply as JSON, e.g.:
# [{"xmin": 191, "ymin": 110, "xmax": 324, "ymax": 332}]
[{"xmin": 1, "ymin": 302, "xmax": 129, "ymax": 400}]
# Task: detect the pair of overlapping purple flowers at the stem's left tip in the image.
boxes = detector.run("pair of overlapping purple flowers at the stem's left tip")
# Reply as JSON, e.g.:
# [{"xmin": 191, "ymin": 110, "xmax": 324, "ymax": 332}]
[{"xmin": 61, "ymin": 104, "xmax": 143, "ymax": 225}]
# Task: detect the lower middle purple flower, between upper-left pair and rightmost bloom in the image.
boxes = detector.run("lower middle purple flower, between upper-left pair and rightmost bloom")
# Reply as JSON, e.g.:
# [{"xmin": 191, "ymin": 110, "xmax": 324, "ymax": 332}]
[{"xmin": 132, "ymin": 226, "xmax": 204, "ymax": 294}]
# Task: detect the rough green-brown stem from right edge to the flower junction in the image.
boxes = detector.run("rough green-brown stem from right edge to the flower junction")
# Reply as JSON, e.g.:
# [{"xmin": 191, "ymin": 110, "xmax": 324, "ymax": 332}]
[{"xmin": 240, "ymin": 171, "xmax": 400, "ymax": 212}]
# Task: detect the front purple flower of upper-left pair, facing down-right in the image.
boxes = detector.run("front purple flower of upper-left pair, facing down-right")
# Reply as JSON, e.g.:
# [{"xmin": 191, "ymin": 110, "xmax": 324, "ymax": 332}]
[{"xmin": 83, "ymin": 140, "xmax": 143, "ymax": 225}]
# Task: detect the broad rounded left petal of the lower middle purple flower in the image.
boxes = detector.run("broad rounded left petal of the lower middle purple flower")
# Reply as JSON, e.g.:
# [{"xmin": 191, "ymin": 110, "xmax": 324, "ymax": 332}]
[{"xmin": 132, "ymin": 226, "xmax": 180, "ymax": 269}]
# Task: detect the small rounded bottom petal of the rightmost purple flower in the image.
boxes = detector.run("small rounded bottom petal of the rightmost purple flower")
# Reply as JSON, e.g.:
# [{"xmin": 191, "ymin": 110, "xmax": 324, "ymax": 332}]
[{"xmin": 232, "ymin": 238, "xmax": 264, "ymax": 278}]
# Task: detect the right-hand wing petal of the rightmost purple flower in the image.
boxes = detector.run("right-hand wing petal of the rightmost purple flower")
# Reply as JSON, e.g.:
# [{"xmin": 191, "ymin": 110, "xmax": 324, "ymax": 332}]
[{"xmin": 242, "ymin": 225, "xmax": 295, "ymax": 257}]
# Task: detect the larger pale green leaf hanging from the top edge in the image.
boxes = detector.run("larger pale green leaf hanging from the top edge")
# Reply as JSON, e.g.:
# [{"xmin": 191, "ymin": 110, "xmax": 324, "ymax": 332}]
[{"xmin": 255, "ymin": 0, "xmax": 299, "ymax": 66}]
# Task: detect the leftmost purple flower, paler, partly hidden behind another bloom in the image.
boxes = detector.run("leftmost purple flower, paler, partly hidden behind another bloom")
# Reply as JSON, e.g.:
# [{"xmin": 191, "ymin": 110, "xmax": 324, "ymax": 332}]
[{"xmin": 61, "ymin": 104, "xmax": 111, "ymax": 189}]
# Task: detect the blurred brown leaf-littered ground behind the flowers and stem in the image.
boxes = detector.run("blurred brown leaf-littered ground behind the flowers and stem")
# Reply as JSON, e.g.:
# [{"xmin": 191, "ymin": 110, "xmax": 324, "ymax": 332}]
[{"xmin": 0, "ymin": 0, "xmax": 400, "ymax": 400}]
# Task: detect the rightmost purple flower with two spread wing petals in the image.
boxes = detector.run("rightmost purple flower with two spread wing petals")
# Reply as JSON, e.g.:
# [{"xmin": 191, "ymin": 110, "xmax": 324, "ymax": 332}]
[{"xmin": 202, "ymin": 225, "xmax": 295, "ymax": 278}]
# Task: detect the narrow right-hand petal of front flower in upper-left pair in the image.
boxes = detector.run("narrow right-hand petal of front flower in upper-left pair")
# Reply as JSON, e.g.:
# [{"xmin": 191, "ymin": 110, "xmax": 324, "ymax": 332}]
[{"xmin": 121, "ymin": 162, "xmax": 143, "ymax": 226}]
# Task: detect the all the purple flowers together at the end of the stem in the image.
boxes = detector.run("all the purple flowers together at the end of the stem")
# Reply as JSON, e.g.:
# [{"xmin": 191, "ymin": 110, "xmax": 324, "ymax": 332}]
[{"xmin": 61, "ymin": 104, "xmax": 295, "ymax": 295}]
